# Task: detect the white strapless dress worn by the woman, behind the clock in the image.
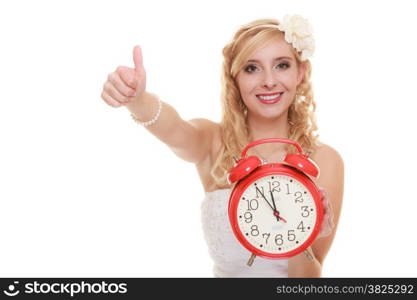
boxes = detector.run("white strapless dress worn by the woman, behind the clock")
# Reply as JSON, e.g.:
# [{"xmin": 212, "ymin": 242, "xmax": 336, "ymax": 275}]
[{"xmin": 201, "ymin": 189, "xmax": 288, "ymax": 277}]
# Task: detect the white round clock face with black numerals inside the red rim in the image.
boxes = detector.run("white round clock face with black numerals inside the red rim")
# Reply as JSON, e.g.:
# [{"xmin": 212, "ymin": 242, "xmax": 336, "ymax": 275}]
[{"xmin": 236, "ymin": 175, "xmax": 318, "ymax": 257}]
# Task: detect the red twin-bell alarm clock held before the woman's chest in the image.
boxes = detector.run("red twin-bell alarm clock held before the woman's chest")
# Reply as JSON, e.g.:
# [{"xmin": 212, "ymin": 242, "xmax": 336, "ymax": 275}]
[{"xmin": 228, "ymin": 138, "xmax": 323, "ymax": 265}]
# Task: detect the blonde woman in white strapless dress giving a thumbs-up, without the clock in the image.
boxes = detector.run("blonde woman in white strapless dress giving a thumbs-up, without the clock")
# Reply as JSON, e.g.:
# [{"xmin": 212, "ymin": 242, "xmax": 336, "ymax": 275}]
[{"xmin": 102, "ymin": 16, "xmax": 344, "ymax": 277}]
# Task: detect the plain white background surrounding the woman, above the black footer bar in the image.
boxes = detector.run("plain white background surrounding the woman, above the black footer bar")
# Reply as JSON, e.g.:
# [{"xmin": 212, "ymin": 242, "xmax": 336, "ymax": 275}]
[{"xmin": 0, "ymin": 0, "xmax": 417, "ymax": 277}]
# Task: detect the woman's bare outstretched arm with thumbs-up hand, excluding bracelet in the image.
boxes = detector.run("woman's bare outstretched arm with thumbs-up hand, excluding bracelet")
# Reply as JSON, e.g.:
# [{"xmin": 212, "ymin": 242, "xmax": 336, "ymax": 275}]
[{"xmin": 101, "ymin": 46, "xmax": 214, "ymax": 163}]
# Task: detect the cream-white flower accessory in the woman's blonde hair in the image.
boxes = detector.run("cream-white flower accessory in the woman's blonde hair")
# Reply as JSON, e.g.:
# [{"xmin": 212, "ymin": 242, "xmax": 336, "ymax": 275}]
[{"xmin": 278, "ymin": 15, "xmax": 315, "ymax": 61}]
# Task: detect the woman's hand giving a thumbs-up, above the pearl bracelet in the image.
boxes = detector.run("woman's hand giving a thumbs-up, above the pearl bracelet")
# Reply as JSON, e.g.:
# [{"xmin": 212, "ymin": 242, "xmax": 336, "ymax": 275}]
[{"xmin": 101, "ymin": 46, "xmax": 146, "ymax": 107}]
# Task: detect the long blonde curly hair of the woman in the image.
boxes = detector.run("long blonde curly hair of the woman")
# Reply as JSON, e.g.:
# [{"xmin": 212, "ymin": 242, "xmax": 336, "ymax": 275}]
[{"xmin": 211, "ymin": 19, "xmax": 319, "ymax": 187}]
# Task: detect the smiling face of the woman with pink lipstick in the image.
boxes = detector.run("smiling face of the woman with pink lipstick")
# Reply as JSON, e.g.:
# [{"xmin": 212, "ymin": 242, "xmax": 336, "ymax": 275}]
[{"xmin": 236, "ymin": 35, "xmax": 305, "ymax": 118}]
